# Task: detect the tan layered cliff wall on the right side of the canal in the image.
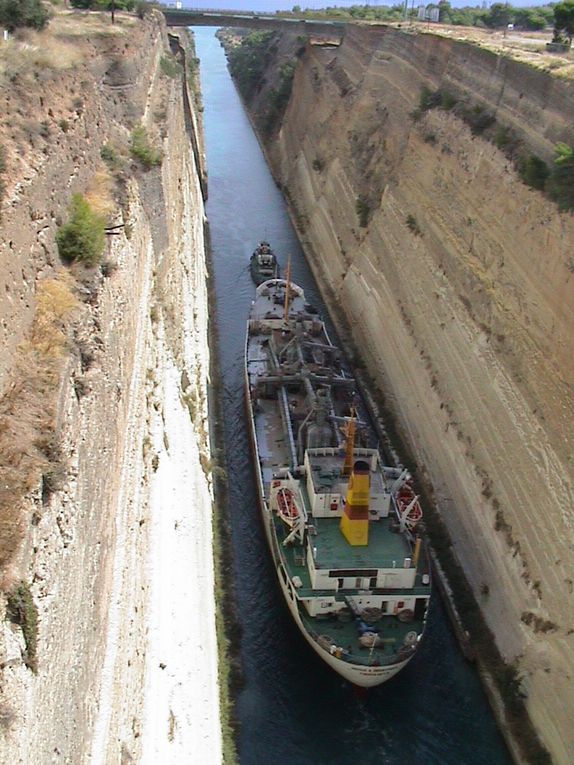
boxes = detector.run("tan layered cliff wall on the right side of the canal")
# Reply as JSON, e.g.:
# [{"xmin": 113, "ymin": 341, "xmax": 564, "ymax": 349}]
[{"xmin": 256, "ymin": 23, "xmax": 574, "ymax": 765}]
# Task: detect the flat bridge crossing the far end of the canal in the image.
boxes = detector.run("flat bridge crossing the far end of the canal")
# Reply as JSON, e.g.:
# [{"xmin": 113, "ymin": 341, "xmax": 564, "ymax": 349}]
[{"xmin": 160, "ymin": 6, "xmax": 346, "ymax": 37}]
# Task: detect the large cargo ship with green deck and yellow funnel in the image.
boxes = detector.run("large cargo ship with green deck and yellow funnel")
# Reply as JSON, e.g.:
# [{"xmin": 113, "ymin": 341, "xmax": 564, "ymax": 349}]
[{"xmin": 245, "ymin": 269, "xmax": 431, "ymax": 688}]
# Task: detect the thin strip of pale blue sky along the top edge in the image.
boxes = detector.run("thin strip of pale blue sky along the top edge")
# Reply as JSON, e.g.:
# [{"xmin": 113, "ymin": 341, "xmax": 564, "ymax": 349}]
[{"xmin": 169, "ymin": 0, "xmax": 556, "ymax": 12}]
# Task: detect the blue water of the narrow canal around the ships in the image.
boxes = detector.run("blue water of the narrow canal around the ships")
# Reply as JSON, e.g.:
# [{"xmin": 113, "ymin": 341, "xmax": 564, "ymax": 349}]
[{"xmin": 194, "ymin": 28, "xmax": 511, "ymax": 765}]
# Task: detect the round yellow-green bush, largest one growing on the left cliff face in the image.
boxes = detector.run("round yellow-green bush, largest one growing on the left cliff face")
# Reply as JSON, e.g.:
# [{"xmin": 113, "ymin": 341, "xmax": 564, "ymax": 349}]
[{"xmin": 56, "ymin": 194, "xmax": 106, "ymax": 266}]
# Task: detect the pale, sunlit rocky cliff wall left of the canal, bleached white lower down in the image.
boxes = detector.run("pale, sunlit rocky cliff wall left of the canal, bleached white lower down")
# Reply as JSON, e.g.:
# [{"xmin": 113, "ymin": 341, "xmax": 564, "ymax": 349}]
[{"xmin": 0, "ymin": 13, "xmax": 221, "ymax": 763}]
